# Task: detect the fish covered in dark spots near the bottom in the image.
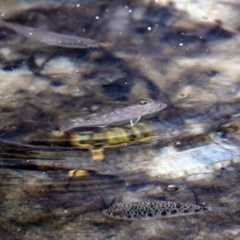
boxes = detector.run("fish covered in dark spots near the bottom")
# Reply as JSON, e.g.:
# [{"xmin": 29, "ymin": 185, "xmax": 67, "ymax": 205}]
[{"xmin": 103, "ymin": 201, "xmax": 208, "ymax": 220}]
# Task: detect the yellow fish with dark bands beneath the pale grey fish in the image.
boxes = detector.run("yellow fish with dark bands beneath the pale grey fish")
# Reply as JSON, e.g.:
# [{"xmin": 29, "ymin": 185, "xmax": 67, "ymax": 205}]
[{"xmin": 51, "ymin": 123, "xmax": 155, "ymax": 161}]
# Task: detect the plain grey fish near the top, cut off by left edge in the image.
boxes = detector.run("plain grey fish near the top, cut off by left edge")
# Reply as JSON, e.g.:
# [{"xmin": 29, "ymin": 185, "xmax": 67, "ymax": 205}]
[{"xmin": 0, "ymin": 20, "xmax": 110, "ymax": 48}]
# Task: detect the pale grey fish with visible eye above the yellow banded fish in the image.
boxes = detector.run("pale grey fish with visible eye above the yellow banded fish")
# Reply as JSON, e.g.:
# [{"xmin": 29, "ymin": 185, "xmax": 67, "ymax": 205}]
[{"xmin": 60, "ymin": 99, "xmax": 167, "ymax": 132}]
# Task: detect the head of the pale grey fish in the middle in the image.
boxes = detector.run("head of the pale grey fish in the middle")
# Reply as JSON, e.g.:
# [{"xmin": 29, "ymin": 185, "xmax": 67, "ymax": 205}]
[{"xmin": 138, "ymin": 99, "xmax": 167, "ymax": 116}]
